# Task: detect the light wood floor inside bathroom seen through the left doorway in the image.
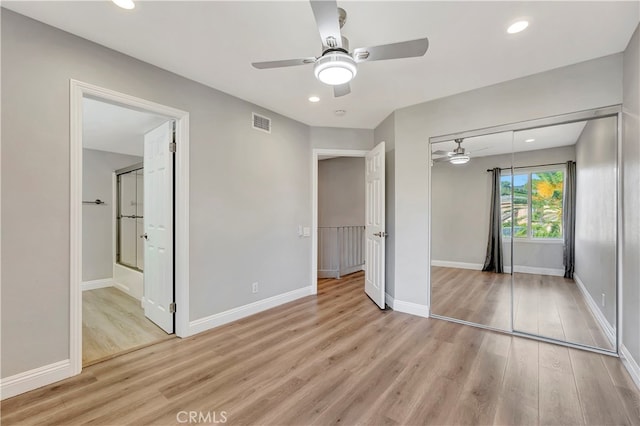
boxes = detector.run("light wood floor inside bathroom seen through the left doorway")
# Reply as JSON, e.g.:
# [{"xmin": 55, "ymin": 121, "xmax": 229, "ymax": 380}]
[{"xmin": 82, "ymin": 287, "xmax": 172, "ymax": 366}]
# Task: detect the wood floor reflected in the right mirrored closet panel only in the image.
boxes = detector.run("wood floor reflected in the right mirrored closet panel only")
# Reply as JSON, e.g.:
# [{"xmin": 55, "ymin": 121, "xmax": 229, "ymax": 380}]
[{"xmin": 513, "ymin": 273, "xmax": 615, "ymax": 350}]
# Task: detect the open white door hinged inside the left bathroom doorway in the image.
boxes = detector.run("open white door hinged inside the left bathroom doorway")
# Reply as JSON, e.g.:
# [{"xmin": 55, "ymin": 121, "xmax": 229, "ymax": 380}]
[{"xmin": 142, "ymin": 121, "xmax": 173, "ymax": 333}]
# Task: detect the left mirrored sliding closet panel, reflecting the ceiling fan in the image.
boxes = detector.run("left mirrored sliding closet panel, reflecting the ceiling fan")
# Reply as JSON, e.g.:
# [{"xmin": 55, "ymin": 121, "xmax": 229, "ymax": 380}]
[{"xmin": 431, "ymin": 132, "xmax": 513, "ymax": 331}]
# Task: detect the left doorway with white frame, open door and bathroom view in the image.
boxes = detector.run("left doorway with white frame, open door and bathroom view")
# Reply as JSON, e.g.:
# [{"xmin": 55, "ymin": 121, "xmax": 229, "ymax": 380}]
[{"xmin": 70, "ymin": 80, "xmax": 189, "ymax": 374}]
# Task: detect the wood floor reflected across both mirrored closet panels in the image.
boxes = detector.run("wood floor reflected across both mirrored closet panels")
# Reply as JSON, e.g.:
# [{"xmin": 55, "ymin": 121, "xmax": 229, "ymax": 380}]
[{"xmin": 431, "ymin": 267, "xmax": 614, "ymax": 349}]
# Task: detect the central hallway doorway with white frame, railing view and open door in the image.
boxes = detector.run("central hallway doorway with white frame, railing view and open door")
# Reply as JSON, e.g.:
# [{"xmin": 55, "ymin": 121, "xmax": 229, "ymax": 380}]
[{"xmin": 311, "ymin": 142, "xmax": 387, "ymax": 309}]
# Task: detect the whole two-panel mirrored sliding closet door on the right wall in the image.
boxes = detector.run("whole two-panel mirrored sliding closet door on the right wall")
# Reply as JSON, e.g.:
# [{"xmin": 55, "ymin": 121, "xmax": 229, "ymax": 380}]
[{"xmin": 430, "ymin": 107, "xmax": 620, "ymax": 353}]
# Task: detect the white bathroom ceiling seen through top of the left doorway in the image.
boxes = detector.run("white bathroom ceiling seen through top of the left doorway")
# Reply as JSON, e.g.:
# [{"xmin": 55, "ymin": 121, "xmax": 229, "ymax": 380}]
[{"xmin": 82, "ymin": 98, "xmax": 167, "ymax": 157}]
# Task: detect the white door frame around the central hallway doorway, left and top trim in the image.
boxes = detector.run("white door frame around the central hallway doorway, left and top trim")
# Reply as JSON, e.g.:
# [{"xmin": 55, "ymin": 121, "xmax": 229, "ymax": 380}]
[{"xmin": 310, "ymin": 148, "xmax": 371, "ymax": 294}]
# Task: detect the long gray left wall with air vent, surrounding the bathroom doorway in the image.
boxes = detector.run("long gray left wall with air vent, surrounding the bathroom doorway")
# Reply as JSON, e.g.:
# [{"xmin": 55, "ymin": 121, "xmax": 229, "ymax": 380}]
[{"xmin": 1, "ymin": 9, "xmax": 310, "ymax": 377}]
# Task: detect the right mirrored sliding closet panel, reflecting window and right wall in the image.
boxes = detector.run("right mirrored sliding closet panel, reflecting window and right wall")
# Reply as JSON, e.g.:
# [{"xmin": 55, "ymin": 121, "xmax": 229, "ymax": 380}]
[{"xmin": 512, "ymin": 116, "xmax": 617, "ymax": 351}]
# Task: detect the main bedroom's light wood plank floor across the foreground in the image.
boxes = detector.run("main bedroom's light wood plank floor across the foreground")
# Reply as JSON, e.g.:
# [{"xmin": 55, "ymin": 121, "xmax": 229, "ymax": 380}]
[{"xmin": 2, "ymin": 273, "xmax": 640, "ymax": 425}]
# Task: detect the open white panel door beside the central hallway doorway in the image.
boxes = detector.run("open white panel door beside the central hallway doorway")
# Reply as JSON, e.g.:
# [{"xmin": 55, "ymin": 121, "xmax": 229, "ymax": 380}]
[{"xmin": 364, "ymin": 142, "xmax": 387, "ymax": 309}]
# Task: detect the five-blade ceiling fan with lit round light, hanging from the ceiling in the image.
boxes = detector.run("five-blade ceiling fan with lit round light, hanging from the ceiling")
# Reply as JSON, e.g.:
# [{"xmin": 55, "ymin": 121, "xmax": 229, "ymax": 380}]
[{"xmin": 251, "ymin": 0, "xmax": 429, "ymax": 97}]
